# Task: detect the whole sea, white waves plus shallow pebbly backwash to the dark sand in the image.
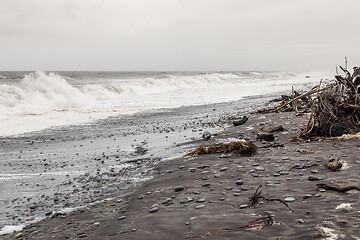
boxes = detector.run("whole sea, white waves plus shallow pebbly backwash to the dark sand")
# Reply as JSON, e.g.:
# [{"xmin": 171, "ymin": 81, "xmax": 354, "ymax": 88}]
[{"xmin": 0, "ymin": 72, "xmax": 331, "ymax": 232}]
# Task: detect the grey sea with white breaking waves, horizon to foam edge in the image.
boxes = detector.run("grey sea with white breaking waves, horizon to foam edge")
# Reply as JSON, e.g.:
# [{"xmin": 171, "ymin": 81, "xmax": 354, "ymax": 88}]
[{"xmin": 0, "ymin": 72, "xmax": 330, "ymax": 136}]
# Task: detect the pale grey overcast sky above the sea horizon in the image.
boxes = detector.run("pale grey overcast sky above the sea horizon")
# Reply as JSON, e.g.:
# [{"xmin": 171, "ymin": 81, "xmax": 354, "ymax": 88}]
[{"xmin": 0, "ymin": 0, "xmax": 360, "ymax": 71}]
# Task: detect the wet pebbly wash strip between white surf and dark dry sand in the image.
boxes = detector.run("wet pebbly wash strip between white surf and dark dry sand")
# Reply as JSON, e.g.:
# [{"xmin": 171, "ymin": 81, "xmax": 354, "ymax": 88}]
[{"xmin": 0, "ymin": 95, "xmax": 273, "ymax": 232}]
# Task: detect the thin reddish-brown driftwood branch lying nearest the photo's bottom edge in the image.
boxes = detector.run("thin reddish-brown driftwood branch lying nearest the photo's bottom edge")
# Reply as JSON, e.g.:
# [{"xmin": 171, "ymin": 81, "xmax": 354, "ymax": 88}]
[{"xmin": 186, "ymin": 215, "xmax": 274, "ymax": 239}]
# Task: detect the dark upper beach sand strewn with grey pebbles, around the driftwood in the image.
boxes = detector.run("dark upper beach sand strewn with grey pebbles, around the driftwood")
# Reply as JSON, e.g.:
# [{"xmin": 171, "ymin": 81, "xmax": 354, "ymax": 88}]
[{"xmin": 0, "ymin": 110, "xmax": 360, "ymax": 240}]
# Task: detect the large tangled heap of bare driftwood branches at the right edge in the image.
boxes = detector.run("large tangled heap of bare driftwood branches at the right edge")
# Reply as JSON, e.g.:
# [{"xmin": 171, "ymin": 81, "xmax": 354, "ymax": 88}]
[{"xmin": 297, "ymin": 63, "xmax": 360, "ymax": 139}]
